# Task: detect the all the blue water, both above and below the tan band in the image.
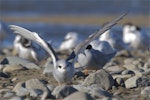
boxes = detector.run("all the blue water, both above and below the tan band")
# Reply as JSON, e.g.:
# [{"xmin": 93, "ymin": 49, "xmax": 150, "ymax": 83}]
[{"xmin": 0, "ymin": 0, "xmax": 150, "ymax": 48}]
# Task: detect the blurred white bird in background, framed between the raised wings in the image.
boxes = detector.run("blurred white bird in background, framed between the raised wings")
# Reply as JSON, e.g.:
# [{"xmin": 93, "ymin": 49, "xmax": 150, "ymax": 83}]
[{"xmin": 59, "ymin": 32, "xmax": 80, "ymax": 50}]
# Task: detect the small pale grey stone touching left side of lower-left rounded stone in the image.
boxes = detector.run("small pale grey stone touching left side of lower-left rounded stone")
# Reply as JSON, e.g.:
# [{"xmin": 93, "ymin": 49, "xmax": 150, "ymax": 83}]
[{"xmin": 12, "ymin": 82, "xmax": 29, "ymax": 96}]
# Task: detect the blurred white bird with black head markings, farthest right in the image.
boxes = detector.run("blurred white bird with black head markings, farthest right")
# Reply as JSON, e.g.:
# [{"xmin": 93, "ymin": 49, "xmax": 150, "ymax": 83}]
[{"xmin": 123, "ymin": 23, "xmax": 150, "ymax": 50}]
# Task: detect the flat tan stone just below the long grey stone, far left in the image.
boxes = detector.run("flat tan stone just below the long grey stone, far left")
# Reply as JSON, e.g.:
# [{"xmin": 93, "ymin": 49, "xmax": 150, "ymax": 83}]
[{"xmin": 3, "ymin": 65, "xmax": 26, "ymax": 72}]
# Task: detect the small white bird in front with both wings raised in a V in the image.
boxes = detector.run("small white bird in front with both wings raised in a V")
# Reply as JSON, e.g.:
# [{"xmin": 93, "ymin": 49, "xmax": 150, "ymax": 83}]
[{"xmin": 10, "ymin": 14, "xmax": 126, "ymax": 84}]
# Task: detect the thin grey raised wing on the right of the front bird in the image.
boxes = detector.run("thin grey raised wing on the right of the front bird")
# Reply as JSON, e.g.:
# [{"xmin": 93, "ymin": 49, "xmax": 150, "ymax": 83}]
[{"xmin": 67, "ymin": 13, "xmax": 127, "ymax": 60}]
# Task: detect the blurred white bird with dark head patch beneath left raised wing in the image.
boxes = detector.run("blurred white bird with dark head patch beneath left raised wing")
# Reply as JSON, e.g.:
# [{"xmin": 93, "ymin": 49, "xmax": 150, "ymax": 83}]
[{"xmin": 13, "ymin": 35, "xmax": 46, "ymax": 62}]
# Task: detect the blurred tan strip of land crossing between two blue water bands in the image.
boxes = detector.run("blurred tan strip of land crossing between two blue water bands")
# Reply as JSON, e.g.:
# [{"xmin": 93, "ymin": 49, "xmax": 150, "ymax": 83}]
[{"xmin": 1, "ymin": 15, "xmax": 150, "ymax": 26}]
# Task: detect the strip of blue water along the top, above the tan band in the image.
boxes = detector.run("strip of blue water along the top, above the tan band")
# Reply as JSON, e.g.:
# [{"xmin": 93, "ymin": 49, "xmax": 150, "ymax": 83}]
[{"xmin": 0, "ymin": 0, "xmax": 150, "ymax": 16}]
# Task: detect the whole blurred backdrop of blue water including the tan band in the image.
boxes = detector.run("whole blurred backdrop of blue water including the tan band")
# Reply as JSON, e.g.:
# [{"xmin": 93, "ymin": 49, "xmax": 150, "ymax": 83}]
[{"xmin": 0, "ymin": 0, "xmax": 150, "ymax": 48}]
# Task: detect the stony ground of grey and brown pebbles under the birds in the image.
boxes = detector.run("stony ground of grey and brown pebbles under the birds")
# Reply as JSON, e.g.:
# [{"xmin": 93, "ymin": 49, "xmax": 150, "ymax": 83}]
[{"xmin": 0, "ymin": 49, "xmax": 150, "ymax": 100}]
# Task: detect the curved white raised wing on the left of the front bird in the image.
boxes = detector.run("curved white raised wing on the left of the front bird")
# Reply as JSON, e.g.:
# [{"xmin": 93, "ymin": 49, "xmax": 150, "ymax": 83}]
[{"xmin": 9, "ymin": 25, "xmax": 58, "ymax": 66}]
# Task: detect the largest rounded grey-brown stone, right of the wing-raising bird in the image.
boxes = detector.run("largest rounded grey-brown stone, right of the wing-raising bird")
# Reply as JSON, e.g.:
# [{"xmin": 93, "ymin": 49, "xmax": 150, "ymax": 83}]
[{"xmin": 83, "ymin": 70, "xmax": 114, "ymax": 90}]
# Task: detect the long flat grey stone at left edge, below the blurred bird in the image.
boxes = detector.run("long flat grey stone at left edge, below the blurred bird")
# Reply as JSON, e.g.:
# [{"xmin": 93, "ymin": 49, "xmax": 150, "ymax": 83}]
[{"xmin": 1, "ymin": 56, "xmax": 40, "ymax": 69}]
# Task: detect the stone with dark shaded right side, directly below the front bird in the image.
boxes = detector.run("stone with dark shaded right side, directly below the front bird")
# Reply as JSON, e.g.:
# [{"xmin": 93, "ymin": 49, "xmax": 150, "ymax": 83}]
[{"xmin": 52, "ymin": 85, "xmax": 77, "ymax": 99}]
